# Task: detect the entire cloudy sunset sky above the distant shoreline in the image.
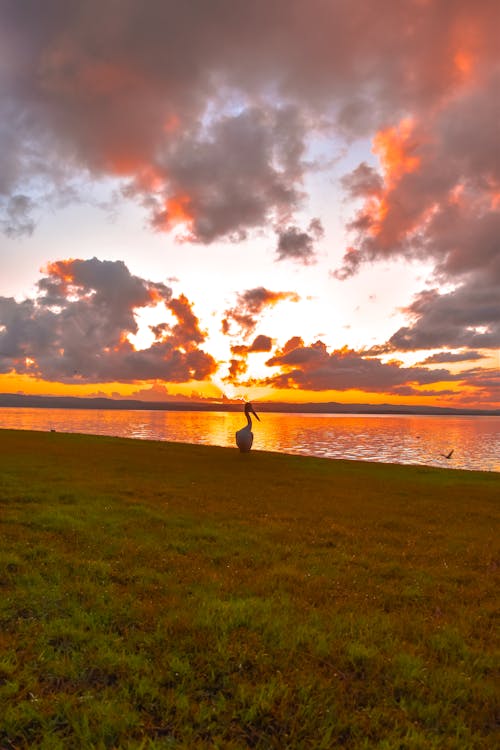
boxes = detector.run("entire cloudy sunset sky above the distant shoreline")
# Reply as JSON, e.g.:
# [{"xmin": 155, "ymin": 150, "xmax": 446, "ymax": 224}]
[{"xmin": 0, "ymin": 0, "xmax": 500, "ymax": 408}]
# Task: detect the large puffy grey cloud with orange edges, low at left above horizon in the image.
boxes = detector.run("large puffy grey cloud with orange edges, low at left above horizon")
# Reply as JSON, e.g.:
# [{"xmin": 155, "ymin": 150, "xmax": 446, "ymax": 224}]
[{"xmin": 0, "ymin": 258, "xmax": 217, "ymax": 383}]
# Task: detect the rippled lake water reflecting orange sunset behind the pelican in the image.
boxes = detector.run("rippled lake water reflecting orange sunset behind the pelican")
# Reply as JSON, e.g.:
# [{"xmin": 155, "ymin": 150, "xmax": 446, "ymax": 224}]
[{"xmin": 0, "ymin": 407, "xmax": 500, "ymax": 471}]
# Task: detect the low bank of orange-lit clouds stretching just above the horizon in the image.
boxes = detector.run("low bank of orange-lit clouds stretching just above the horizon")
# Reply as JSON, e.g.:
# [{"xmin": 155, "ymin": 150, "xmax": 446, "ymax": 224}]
[{"xmin": 0, "ymin": 258, "xmax": 500, "ymax": 403}]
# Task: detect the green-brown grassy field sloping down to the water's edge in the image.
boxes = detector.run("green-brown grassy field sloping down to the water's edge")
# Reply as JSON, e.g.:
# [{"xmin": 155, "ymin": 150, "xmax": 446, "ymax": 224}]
[{"xmin": 0, "ymin": 430, "xmax": 500, "ymax": 750}]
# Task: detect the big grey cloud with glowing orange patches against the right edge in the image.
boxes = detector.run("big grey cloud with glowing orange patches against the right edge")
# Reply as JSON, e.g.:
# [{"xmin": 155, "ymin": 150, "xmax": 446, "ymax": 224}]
[{"xmin": 334, "ymin": 63, "xmax": 500, "ymax": 351}]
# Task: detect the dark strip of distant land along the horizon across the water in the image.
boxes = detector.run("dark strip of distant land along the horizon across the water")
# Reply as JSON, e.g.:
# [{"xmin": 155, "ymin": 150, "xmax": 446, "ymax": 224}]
[{"xmin": 0, "ymin": 393, "xmax": 500, "ymax": 417}]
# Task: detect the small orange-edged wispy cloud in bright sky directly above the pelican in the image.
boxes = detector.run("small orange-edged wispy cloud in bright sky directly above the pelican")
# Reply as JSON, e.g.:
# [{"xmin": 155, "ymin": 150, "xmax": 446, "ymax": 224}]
[{"xmin": 222, "ymin": 286, "xmax": 300, "ymax": 339}]
